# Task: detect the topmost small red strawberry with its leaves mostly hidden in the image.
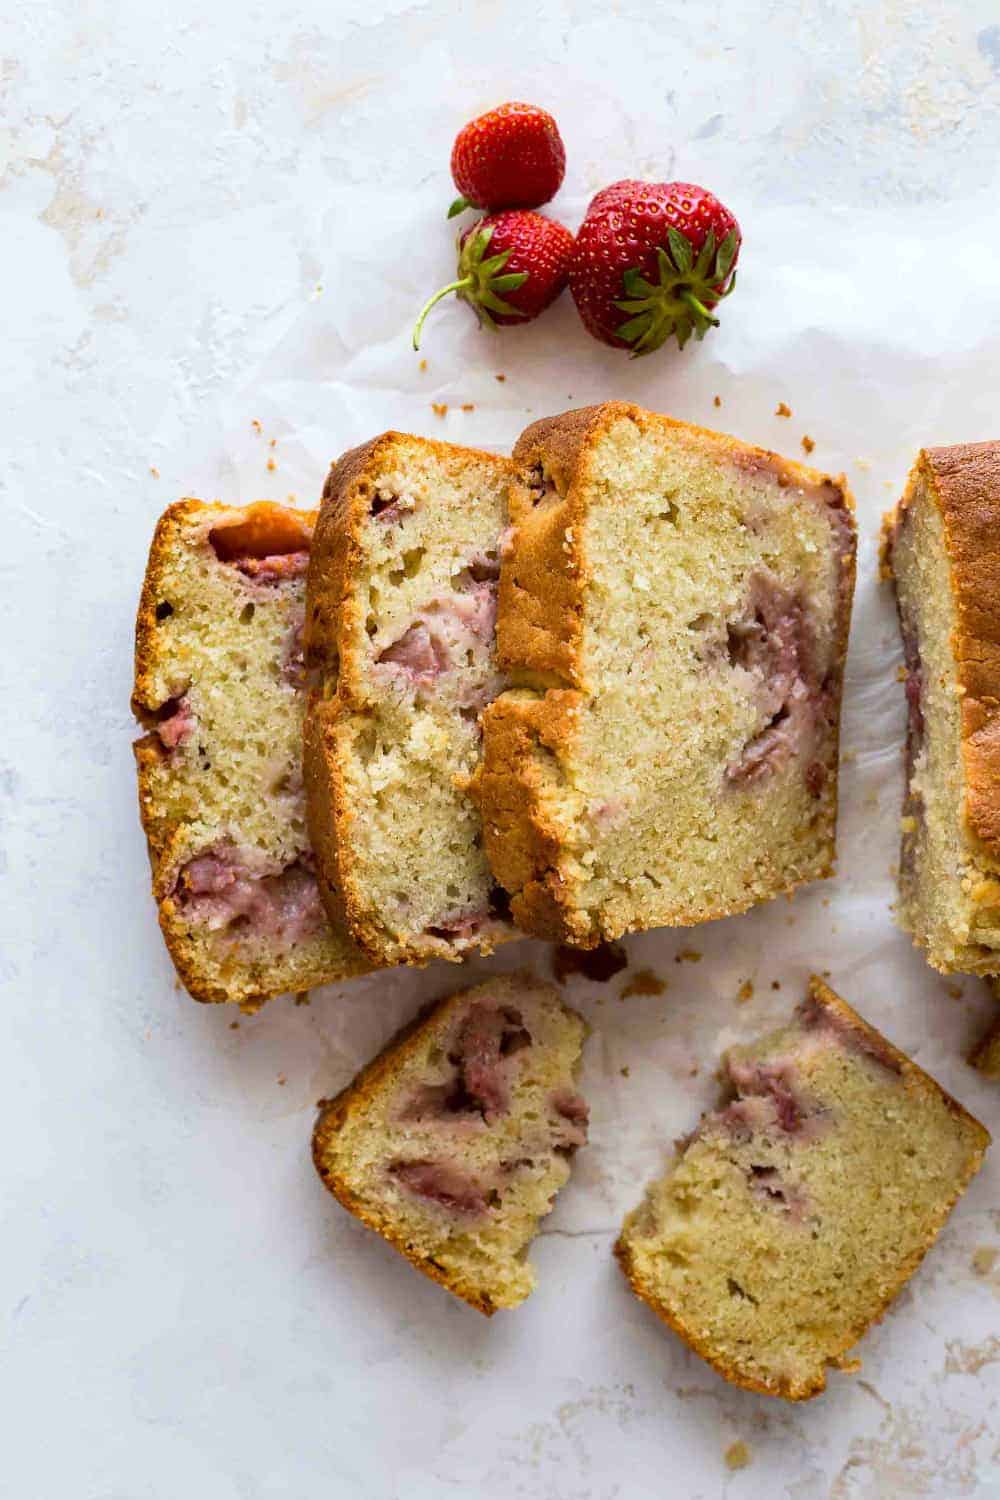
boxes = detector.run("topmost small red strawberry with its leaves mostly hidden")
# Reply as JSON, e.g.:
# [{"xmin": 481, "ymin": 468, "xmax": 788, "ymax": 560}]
[{"xmin": 448, "ymin": 104, "xmax": 565, "ymax": 219}]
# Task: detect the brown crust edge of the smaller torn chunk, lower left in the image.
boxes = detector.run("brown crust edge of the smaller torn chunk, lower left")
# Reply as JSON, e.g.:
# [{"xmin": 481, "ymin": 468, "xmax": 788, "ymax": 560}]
[{"xmin": 312, "ymin": 974, "xmax": 588, "ymax": 1317}]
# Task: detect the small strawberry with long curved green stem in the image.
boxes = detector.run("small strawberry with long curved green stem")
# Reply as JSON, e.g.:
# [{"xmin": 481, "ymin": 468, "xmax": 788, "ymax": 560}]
[{"xmin": 414, "ymin": 209, "xmax": 573, "ymax": 350}]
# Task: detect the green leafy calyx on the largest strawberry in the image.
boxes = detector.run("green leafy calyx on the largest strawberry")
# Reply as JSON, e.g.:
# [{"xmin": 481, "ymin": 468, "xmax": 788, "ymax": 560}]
[{"xmin": 615, "ymin": 227, "xmax": 739, "ymax": 357}]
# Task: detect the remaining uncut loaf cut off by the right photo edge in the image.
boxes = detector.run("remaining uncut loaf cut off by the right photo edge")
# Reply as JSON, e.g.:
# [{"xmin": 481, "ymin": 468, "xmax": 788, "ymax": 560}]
[{"xmin": 882, "ymin": 443, "xmax": 1000, "ymax": 974}]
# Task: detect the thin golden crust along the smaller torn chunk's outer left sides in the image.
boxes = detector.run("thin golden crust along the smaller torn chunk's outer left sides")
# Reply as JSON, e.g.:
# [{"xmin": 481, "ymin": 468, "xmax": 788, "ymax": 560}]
[{"xmin": 312, "ymin": 972, "xmax": 585, "ymax": 1317}]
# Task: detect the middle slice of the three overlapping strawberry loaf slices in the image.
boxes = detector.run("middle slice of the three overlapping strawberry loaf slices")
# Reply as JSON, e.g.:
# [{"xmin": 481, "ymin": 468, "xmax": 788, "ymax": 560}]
[{"xmin": 304, "ymin": 432, "xmax": 524, "ymax": 963}]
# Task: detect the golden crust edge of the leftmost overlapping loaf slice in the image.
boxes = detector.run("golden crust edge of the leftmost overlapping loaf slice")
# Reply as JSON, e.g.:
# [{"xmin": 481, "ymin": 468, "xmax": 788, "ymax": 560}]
[{"xmin": 132, "ymin": 497, "xmax": 372, "ymax": 1011}]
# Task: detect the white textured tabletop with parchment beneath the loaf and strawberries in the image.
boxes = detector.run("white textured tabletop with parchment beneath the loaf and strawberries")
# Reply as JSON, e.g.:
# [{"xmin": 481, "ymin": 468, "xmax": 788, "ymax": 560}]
[{"xmin": 0, "ymin": 0, "xmax": 1000, "ymax": 1500}]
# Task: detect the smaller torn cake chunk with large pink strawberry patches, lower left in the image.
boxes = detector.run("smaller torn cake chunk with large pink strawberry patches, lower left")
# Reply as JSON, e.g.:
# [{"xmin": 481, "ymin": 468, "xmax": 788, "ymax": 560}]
[{"xmin": 313, "ymin": 975, "xmax": 588, "ymax": 1316}]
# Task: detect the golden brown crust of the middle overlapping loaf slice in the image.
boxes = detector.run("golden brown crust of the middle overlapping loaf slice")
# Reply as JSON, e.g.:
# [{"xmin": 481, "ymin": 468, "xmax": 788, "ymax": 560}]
[{"xmin": 303, "ymin": 432, "xmax": 507, "ymax": 966}]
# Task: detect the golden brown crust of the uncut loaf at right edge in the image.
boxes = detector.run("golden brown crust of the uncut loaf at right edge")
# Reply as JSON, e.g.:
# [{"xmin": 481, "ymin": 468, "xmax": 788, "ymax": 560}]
[{"xmin": 883, "ymin": 441, "xmax": 1000, "ymax": 860}]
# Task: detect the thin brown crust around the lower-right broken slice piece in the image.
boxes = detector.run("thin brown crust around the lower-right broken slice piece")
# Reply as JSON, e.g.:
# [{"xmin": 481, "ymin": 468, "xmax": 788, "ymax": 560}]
[{"xmin": 615, "ymin": 975, "xmax": 990, "ymax": 1401}]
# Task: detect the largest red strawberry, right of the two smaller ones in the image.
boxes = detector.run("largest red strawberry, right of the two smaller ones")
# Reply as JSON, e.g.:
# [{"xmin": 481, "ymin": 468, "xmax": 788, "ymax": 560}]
[{"xmin": 570, "ymin": 182, "xmax": 742, "ymax": 354}]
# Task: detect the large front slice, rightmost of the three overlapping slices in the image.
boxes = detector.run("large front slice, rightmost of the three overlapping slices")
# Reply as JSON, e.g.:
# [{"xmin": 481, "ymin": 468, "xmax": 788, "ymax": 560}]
[{"xmin": 472, "ymin": 402, "xmax": 855, "ymax": 947}]
